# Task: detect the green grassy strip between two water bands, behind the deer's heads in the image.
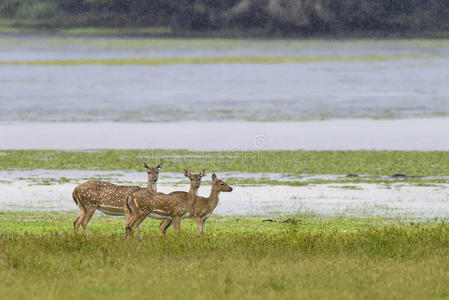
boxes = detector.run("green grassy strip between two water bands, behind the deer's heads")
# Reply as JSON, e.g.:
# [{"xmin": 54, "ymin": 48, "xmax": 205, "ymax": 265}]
[{"xmin": 0, "ymin": 150, "xmax": 449, "ymax": 177}]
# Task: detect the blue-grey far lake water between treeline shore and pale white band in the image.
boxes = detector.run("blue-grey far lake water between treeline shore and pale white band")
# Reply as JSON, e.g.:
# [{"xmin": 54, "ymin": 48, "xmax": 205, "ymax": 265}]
[{"xmin": 0, "ymin": 37, "xmax": 449, "ymax": 122}]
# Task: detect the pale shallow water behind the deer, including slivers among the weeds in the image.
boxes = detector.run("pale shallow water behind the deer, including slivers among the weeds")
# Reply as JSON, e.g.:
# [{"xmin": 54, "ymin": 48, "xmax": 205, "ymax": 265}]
[{"xmin": 0, "ymin": 170, "xmax": 449, "ymax": 220}]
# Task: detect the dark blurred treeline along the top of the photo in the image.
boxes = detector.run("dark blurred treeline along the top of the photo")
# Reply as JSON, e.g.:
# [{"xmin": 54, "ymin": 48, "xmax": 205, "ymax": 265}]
[{"xmin": 0, "ymin": 0, "xmax": 449, "ymax": 36}]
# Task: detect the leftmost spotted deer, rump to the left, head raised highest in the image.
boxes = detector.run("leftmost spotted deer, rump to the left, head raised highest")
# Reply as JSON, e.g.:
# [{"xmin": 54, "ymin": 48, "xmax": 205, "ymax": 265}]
[{"xmin": 72, "ymin": 163, "xmax": 162, "ymax": 234}]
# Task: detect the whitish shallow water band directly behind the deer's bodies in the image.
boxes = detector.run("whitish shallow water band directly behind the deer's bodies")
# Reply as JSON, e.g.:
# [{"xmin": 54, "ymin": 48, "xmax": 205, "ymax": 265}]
[{"xmin": 0, "ymin": 181, "xmax": 449, "ymax": 220}]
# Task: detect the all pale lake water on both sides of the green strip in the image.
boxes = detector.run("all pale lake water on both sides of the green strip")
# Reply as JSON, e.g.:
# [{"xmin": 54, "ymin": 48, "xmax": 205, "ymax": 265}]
[{"xmin": 0, "ymin": 36, "xmax": 449, "ymax": 219}]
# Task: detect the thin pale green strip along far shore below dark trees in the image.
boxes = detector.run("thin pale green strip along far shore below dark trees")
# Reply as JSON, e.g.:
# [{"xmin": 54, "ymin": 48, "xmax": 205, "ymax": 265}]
[{"xmin": 0, "ymin": 35, "xmax": 449, "ymax": 49}]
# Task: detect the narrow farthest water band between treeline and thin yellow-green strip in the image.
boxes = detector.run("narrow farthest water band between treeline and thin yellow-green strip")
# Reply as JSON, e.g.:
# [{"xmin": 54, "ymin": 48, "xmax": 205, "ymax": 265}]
[{"xmin": 0, "ymin": 35, "xmax": 449, "ymax": 61}]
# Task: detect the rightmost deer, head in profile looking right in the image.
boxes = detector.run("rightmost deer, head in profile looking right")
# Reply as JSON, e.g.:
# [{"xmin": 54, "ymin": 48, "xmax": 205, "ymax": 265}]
[{"xmin": 159, "ymin": 174, "xmax": 232, "ymax": 234}]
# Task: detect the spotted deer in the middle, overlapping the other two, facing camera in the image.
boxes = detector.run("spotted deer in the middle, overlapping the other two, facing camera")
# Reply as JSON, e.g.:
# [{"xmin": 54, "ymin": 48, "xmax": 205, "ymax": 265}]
[{"xmin": 124, "ymin": 170, "xmax": 206, "ymax": 238}]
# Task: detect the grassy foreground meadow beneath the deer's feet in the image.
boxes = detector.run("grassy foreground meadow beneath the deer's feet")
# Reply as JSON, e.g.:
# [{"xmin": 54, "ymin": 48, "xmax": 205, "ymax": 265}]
[{"xmin": 0, "ymin": 212, "xmax": 449, "ymax": 299}]
